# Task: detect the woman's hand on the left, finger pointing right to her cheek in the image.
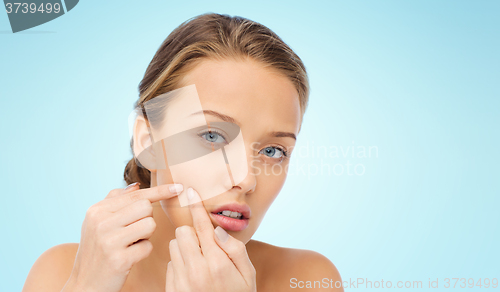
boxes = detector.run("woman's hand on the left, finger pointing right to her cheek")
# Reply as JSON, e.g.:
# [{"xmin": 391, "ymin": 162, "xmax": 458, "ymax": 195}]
[{"xmin": 67, "ymin": 184, "xmax": 182, "ymax": 292}]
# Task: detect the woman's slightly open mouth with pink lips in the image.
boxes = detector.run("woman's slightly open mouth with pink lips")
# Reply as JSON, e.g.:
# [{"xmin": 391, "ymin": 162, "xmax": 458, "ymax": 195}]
[{"xmin": 210, "ymin": 204, "xmax": 250, "ymax": 231}]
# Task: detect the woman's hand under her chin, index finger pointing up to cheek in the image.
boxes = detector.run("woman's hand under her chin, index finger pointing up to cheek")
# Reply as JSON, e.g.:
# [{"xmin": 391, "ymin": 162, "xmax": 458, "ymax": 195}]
[{"xmin": 166, "ymin": 188, "xmax": 257, "ymax": 292}]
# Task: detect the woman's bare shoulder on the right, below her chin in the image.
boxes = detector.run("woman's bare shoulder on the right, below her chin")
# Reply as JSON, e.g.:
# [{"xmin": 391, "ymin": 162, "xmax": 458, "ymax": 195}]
[{"xmin": 247, "ymin": 240, "xmax": 343, "ymax": 291}]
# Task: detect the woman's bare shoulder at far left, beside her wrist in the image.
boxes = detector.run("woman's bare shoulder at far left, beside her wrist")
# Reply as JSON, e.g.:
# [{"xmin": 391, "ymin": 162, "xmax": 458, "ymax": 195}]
[{"xmin": 22, "ymin": 243, "xmax": 78, "ymax": 292}]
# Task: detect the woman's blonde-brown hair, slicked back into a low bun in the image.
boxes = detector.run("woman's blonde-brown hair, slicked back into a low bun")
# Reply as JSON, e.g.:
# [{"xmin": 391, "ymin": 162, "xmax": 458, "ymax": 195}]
[{"xmin": 124, "ymin": 13, "xmax": 309, "ymax": 188}]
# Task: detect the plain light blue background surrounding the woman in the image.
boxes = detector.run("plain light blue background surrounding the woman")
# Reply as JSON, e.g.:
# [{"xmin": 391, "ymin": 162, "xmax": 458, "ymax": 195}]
[{"xmin": 0, "ymin": 1, "xmax": 500, "ymax": 291}]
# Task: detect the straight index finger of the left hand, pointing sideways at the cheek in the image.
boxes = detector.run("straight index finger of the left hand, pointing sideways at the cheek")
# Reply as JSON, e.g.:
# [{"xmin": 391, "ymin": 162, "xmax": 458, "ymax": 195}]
[{"xmin": 111, "ymin": 184, "xmax": 183, "ymax": 212}]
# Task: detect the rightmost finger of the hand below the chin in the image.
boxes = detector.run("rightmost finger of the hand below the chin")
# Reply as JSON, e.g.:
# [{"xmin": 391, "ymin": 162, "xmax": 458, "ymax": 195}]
[{"xmin": 214, "ymin": 226, "xmax": 255, "ymax": 283}]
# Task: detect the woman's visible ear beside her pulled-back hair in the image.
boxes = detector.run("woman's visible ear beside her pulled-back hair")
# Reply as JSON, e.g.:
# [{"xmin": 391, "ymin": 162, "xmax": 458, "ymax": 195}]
[{"xmin": 132, "ymin": 114, "xmax": 157, "ymax": 171}]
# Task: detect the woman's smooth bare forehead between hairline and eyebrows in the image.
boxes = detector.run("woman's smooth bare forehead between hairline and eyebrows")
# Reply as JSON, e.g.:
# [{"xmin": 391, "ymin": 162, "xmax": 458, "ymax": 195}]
[{"xmin": 181, "ymin": 59, "xmax": 301, "ymax": 134}]
